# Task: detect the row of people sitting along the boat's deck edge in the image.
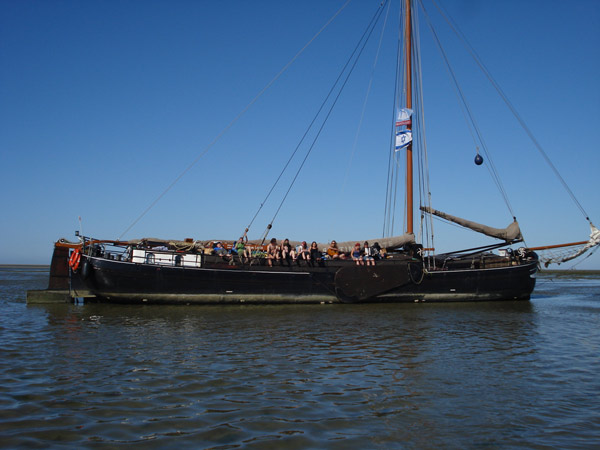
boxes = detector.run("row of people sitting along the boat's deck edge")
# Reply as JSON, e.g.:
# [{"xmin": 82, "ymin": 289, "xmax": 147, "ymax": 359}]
[{"xmin": 213, "ymin": 236, "xmax": 386, "ymax": 267}]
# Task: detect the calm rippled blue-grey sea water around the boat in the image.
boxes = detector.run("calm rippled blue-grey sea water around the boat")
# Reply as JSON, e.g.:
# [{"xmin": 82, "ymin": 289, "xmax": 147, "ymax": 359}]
[{"xmin": 0, "ymin": 268, "xmax": 600, "ymax": 449}]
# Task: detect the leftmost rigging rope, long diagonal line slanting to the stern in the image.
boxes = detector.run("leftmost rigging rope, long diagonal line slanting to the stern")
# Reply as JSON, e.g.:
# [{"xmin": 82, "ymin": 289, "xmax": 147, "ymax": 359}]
[{"xmin": 118, "ymin": 0, "xmax": 350, "ymax": 240}]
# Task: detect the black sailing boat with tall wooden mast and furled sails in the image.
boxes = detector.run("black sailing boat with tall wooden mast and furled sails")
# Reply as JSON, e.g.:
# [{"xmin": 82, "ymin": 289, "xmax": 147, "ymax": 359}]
[{"xmin": 45, "ymin": 0, "xmax": 600, "ymax": 303}]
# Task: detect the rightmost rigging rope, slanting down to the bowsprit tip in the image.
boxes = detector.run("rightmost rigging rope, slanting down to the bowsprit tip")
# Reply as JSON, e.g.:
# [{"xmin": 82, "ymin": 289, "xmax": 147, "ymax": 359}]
[{"xmin": 432, "ymin": 0, "xmax": 591, "ymax": 223}]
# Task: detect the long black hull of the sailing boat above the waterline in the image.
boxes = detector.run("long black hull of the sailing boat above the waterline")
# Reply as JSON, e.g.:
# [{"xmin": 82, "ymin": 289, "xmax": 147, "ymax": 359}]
[{"xmin": 76, "ymin": 256, "xmax": 537, "ymax": 304}]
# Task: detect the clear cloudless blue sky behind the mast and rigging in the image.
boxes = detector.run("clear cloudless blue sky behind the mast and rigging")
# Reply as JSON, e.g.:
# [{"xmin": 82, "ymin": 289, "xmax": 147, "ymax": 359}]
[{"xmin": 0, "ymin": 0, "xmax": 600, "ymax": 269}]
